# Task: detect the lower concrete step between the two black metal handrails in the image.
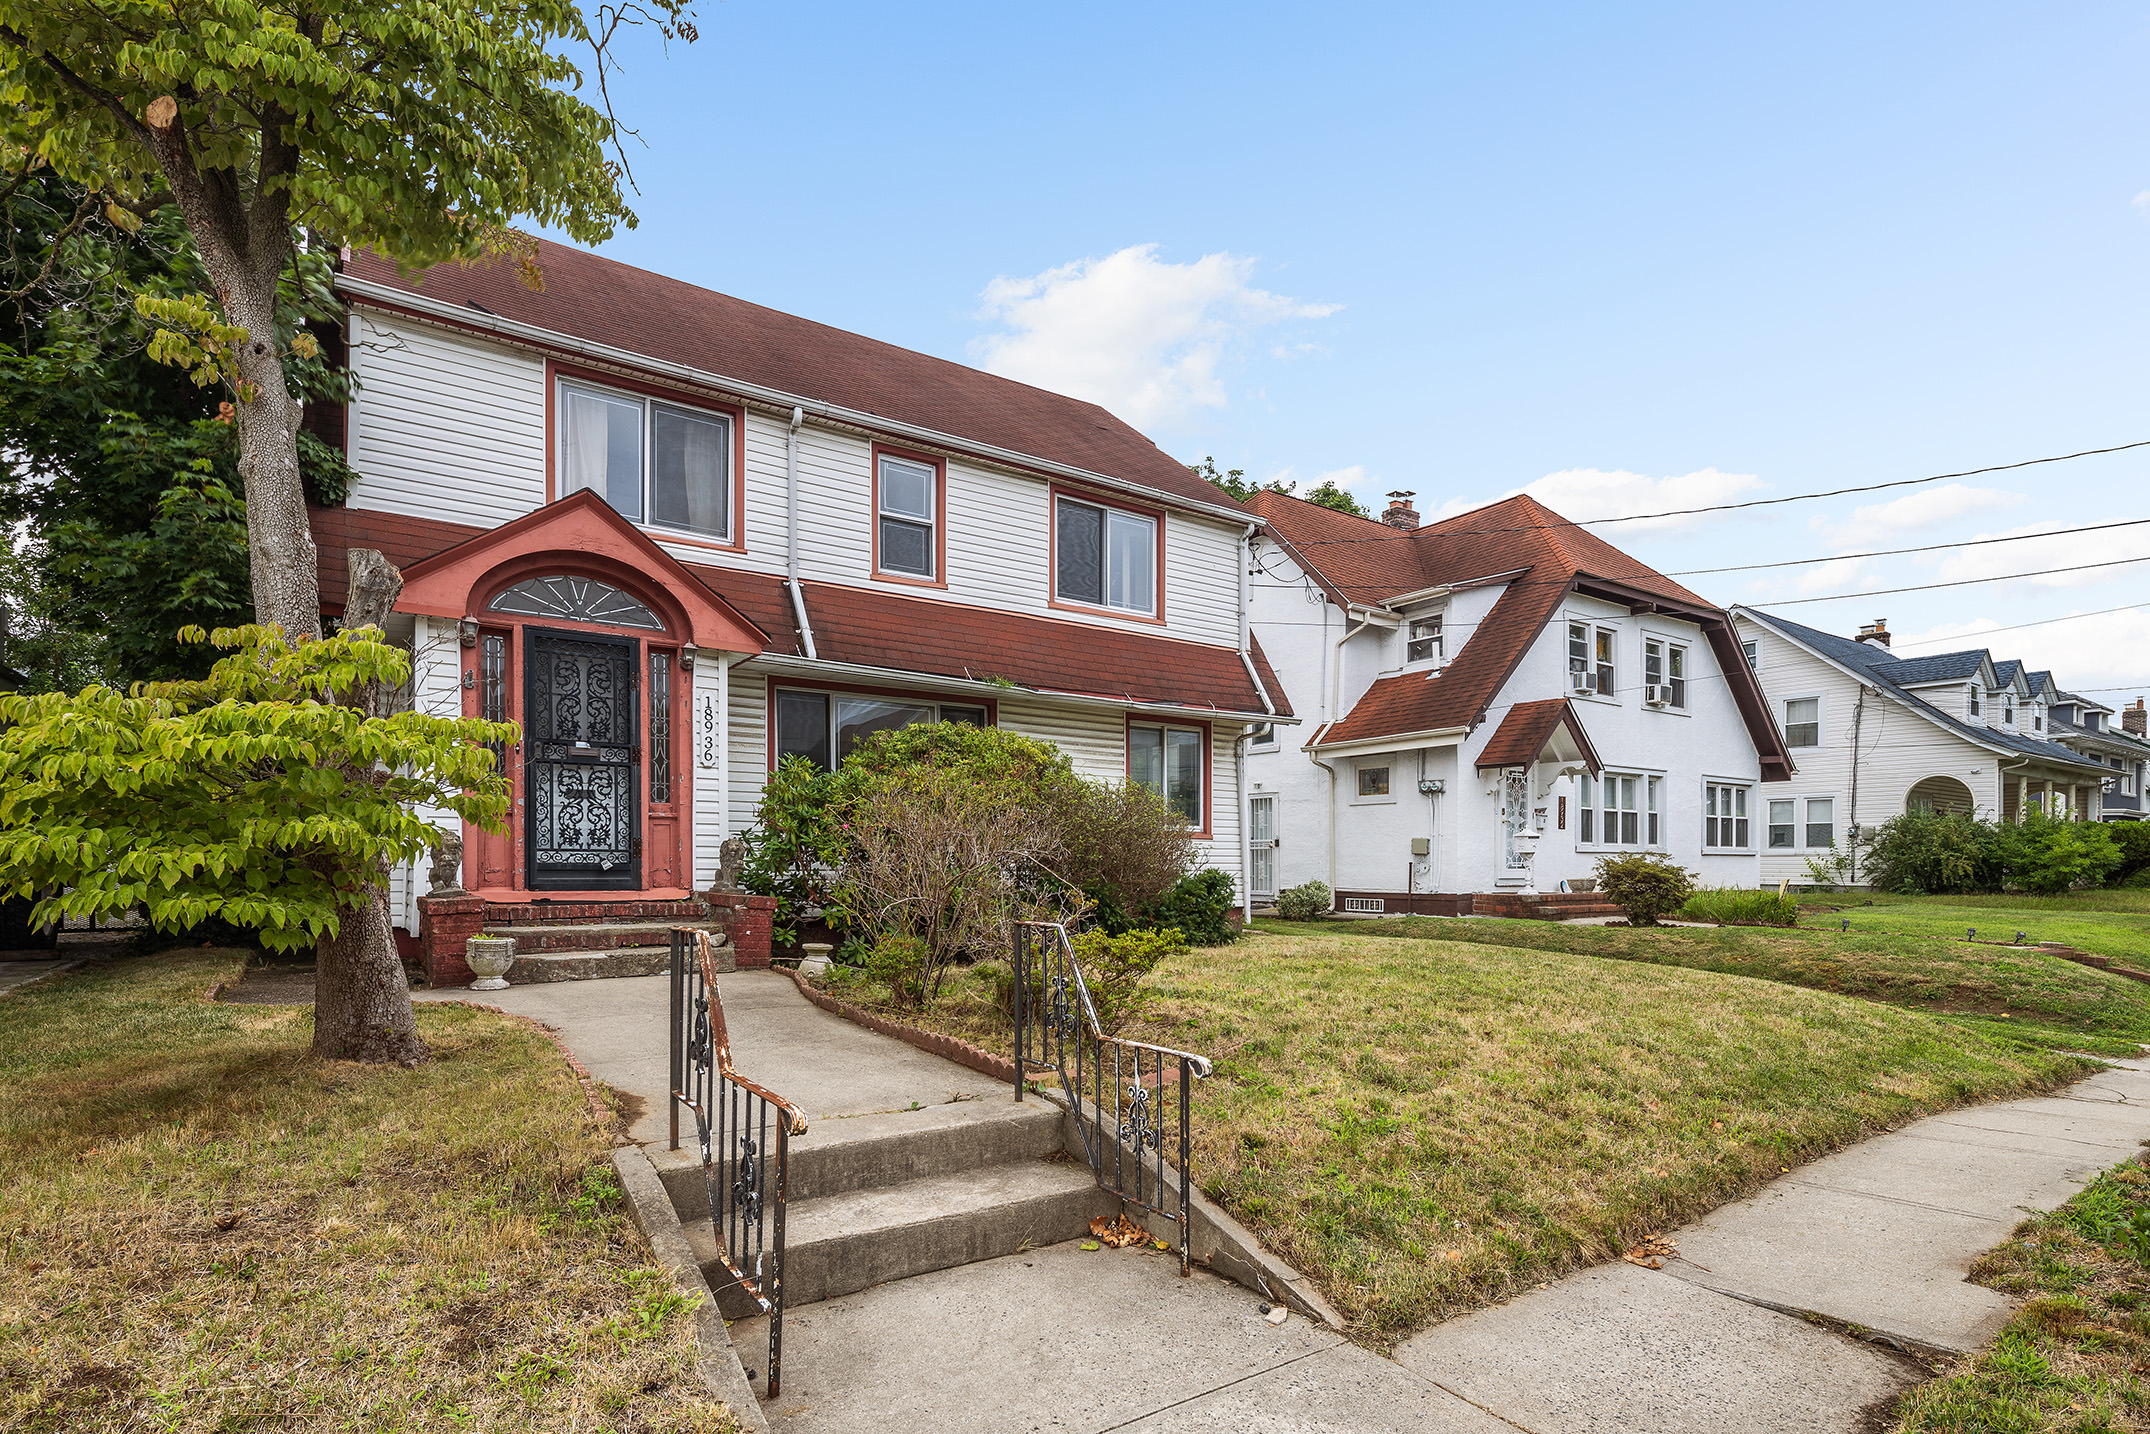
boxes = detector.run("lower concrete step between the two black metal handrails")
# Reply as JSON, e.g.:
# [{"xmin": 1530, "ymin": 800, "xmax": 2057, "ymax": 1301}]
[{"xmin": 686, "ymin": 1159, "xmax": 1120, "ymax": 1318}]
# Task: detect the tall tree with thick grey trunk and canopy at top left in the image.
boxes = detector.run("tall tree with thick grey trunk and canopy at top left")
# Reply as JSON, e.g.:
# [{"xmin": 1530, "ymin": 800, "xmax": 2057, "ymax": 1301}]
[{"xmin": 0, "ymin": 0, "xmax": 694, "ymax": 1056}]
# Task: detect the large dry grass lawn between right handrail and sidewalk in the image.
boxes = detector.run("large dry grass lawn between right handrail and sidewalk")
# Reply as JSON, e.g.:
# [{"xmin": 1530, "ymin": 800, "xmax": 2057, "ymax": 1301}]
[{"xmin": 817, "ymin": 922, "xmax": 2088, "ymax": 1346}]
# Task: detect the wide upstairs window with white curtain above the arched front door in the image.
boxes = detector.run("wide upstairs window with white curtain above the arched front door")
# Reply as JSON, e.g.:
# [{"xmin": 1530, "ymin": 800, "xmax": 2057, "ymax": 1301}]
[{"xmin": 559, "ymin": 381, "xmax": 733, "ymax": 542}]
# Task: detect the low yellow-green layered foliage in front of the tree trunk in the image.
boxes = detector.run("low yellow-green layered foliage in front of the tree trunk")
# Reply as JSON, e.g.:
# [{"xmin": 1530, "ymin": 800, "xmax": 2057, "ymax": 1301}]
[{"xmin": 0, "ymin": 626, "xmax": 516, "ymax": 1062}]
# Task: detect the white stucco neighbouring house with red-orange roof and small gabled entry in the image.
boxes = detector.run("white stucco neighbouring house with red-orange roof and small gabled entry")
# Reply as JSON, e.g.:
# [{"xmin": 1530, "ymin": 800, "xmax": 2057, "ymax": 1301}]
[{"xmin": 1247, "ymin": 492, "xmax": 1791, "ymax": 914}]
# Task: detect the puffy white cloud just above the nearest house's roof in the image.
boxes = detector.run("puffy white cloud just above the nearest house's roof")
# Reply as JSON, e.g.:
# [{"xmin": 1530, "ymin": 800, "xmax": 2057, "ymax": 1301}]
[{"xmin": 972, "ymin": 243, "xmax": 1342, "ymax": 428}]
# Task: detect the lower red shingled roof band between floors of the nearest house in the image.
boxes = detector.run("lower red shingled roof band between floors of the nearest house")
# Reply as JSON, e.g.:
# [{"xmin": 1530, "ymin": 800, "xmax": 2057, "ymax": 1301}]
[{"xmin": 310, "ymin": 507, "xmax": 1292, "ymax": 716}]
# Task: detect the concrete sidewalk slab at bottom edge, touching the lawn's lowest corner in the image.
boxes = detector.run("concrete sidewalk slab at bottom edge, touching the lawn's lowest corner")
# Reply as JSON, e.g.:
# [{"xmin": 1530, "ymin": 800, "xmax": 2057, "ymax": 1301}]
[{"xmin": 1395, "ymin": 1264, "xmax": 1924, "ymax": 1434}]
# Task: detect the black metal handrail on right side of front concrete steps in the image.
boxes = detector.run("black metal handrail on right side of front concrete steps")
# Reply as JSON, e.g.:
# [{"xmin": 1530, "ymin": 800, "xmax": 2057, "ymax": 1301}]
[{"xmin": 1015, "ymin": 920, "xmax": 1210, "ymax": 1275}]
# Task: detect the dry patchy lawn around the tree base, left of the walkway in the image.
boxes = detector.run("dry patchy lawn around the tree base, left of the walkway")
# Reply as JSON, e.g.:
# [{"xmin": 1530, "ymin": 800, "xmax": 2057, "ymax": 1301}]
[{"xmin": 0, "ymin": 950, "xmax": 737, "ymax": 1434}]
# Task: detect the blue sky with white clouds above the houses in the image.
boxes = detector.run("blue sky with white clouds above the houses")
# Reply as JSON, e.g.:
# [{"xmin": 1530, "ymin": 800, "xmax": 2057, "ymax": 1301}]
[{"xmin": 580, "ymin": 0, "xmax": 2150, "ymax": 699}]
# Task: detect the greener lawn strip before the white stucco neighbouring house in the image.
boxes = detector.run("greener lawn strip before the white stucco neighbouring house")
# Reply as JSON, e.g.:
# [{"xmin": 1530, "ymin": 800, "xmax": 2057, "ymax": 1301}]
[{"xmin": 1281, "ymin": 915, "xmax": 2150, "ymax": 1056}]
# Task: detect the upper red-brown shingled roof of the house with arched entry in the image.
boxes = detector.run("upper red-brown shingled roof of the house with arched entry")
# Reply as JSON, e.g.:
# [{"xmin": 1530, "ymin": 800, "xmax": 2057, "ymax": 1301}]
[{"xmin": 344, "ymin": 239, "xmax": 1232, "ymax": 507}]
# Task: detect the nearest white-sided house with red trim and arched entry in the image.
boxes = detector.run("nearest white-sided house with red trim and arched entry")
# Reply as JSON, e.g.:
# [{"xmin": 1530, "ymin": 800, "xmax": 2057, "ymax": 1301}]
[{"xmin": 307, "ymin": 243, "xmax": 1292, "ymax": 954}]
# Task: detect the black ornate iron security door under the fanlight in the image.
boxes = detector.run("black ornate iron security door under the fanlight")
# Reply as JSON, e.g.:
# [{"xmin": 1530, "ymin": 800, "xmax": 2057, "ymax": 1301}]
[{"xmin": 522, "ymin": 628, "xmax": 643, "ymax": 890}]
